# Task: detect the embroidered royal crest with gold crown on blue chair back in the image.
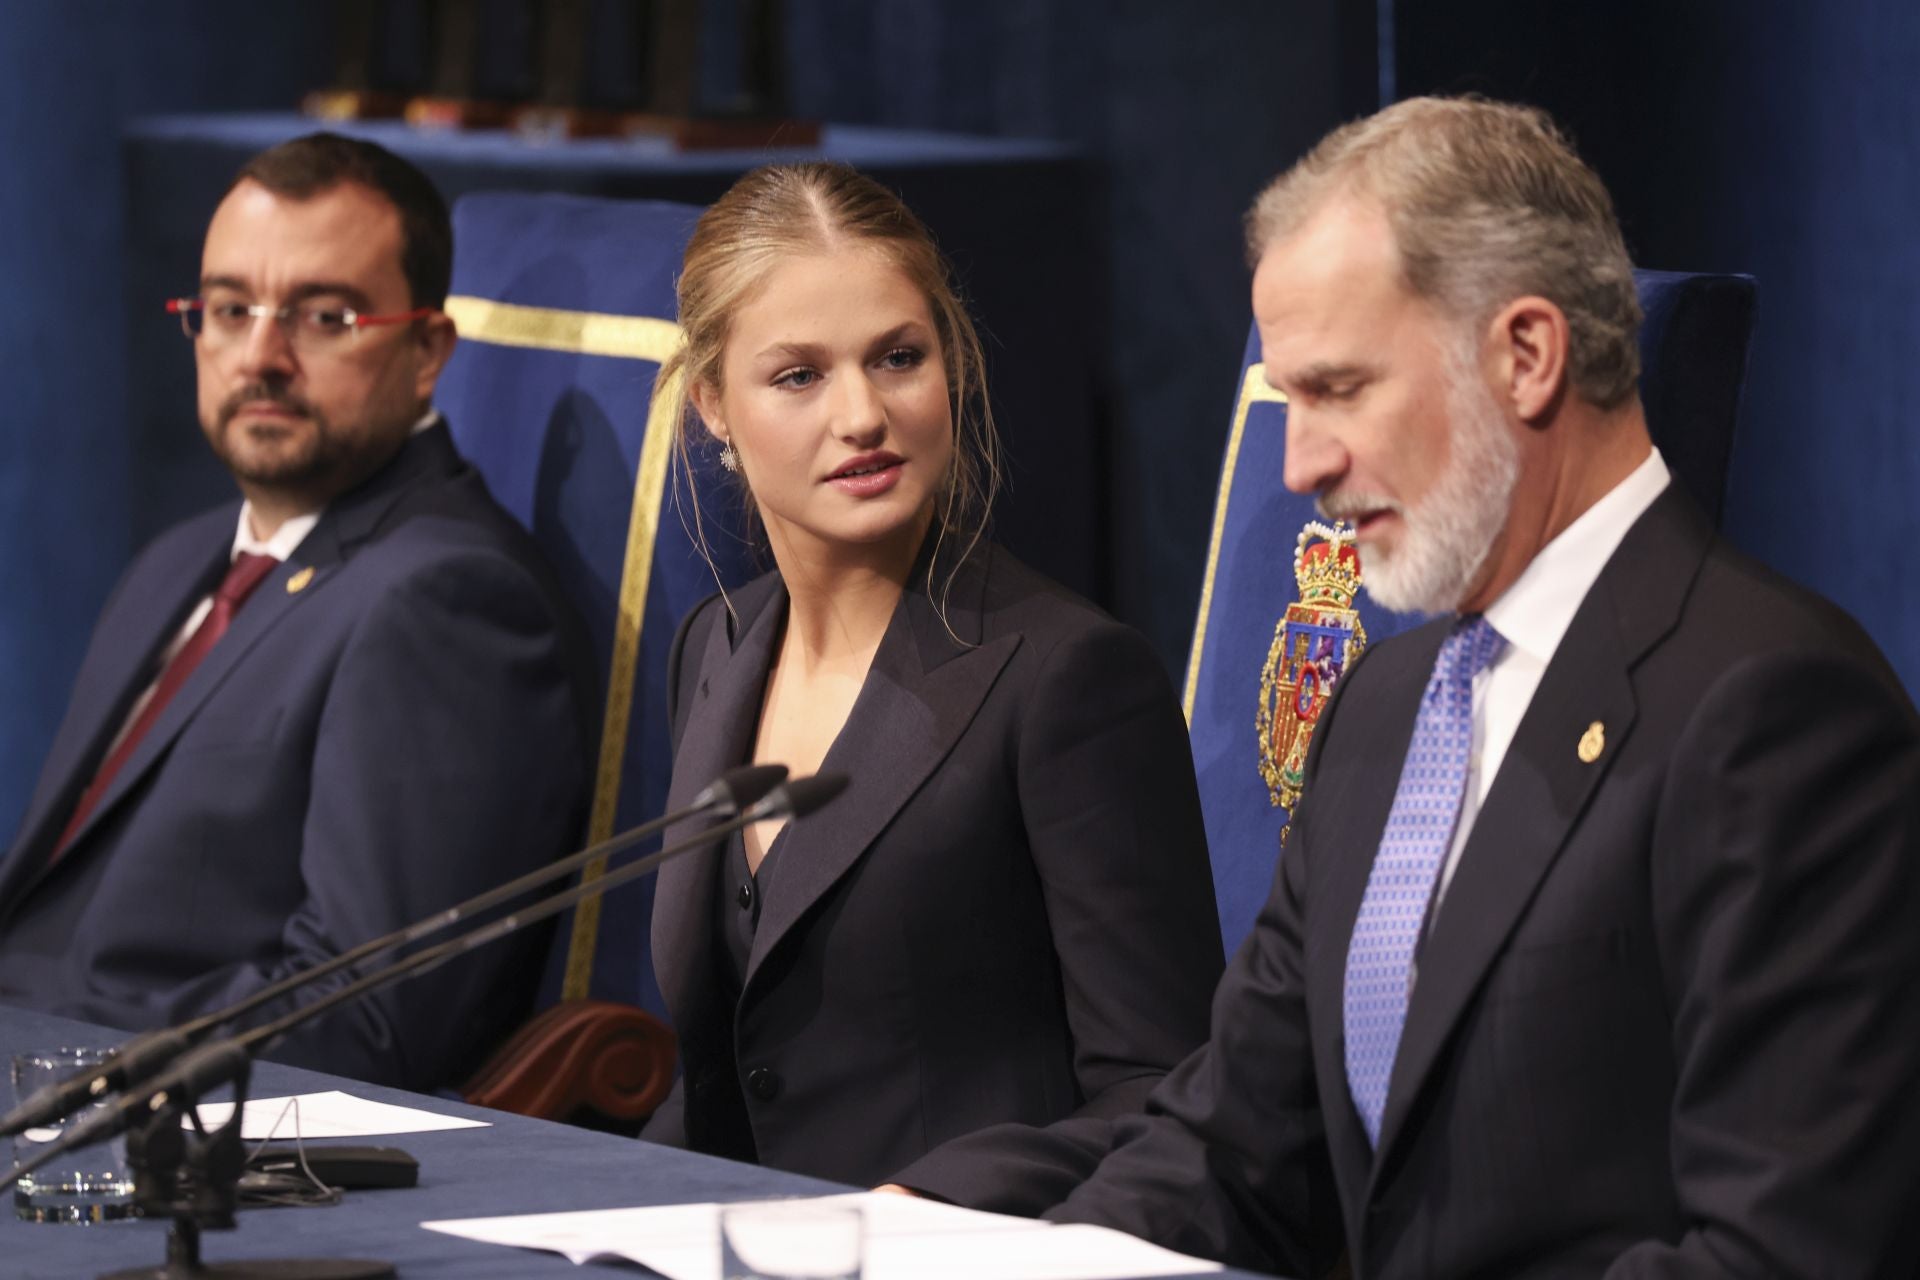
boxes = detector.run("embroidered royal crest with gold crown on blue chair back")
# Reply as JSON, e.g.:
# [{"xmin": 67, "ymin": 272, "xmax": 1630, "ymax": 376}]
[{"xmin": 1256, "ymin": 520, "xmax": 1367, "ymax": 817}]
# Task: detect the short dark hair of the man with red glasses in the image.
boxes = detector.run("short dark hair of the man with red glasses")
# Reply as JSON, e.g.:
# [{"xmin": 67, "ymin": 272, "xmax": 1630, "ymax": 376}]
[{"xmin": 227, "ymin": 132, "xmax": 453, "ymax": 309}]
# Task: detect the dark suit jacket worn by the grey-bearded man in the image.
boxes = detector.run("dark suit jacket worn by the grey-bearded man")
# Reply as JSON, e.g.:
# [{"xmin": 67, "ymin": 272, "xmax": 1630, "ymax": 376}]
[{"xmin": 1021, "ymin": 487, "xmax": 1920, "ymax": 1278}]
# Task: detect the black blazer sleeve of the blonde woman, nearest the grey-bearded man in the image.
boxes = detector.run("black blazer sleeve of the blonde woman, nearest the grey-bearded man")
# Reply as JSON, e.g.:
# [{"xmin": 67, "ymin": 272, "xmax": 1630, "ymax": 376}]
[{"xmin": 897, "ymin": 622, "xmax": 1223, "ymax": 1213}]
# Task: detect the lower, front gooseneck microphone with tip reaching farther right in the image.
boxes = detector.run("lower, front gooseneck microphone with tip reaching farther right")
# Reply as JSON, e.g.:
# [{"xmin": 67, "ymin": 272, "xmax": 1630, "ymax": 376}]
[{"xmin": 0, "ymin": 773, "xmax": 847, "ymax": 1192}]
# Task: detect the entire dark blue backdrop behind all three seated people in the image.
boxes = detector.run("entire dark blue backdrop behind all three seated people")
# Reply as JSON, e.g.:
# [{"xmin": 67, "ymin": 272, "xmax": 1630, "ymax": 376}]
[{"xmin": 0, "ymin": 0, "xmax": 1920, "ymax": 835}]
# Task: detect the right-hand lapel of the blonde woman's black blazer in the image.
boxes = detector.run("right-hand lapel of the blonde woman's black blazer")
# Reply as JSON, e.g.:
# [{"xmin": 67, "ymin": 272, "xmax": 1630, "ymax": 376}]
[{"xmin": 747, "ymin": 551, "xmax": 1020, "ymax": 990}]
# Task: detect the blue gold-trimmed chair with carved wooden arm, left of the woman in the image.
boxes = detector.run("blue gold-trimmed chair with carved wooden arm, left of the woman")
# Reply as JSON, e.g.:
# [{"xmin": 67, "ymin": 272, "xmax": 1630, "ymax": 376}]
[{"xmin": 438, "ymin": 194, "xmax": 747, "ymax": 1123}]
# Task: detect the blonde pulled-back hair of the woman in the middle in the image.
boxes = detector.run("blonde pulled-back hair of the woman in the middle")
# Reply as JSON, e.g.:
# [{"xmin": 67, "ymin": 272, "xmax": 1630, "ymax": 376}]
[{"xmin": 655, "ymin": 161, "xmax": 1000, "ymax": 606}]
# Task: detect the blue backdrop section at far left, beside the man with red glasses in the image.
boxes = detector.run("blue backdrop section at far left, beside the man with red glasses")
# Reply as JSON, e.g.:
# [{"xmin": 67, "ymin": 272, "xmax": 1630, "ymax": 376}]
[{"xmin": 0, "ymin": 0, "xmax": 330, "ymax": 842}]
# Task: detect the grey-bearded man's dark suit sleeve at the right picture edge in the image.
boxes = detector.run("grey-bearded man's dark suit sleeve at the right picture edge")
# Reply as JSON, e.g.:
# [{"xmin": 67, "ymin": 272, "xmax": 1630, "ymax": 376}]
[{"xmin": 1607, "ymin": 652, "xmax": 1920, "ymax": 1280}]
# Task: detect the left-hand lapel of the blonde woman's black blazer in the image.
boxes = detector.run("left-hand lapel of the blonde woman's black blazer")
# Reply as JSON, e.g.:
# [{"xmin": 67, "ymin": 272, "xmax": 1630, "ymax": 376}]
[{"xmin": 653, "ymin": 574, "xmax": 791, "ymax": 1027}]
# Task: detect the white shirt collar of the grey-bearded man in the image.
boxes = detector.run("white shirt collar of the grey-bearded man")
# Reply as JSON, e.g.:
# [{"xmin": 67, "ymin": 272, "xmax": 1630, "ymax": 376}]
[{"xmin": 1486, "ymin": 449, "xmax": 1672, "ymax": 666}]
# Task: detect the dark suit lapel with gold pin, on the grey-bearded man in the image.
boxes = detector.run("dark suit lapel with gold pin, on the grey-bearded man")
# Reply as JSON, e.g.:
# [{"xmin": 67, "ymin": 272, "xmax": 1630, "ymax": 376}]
[{"xmin": 1375, "ymin": 487, "xmax": 1711, "ymax": 1171}]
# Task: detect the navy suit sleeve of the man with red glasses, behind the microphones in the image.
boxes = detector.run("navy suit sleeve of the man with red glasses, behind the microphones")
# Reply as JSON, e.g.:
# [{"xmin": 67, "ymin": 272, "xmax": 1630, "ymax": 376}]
[{"xmin": 63, "ymin": 553, "xmax": 591, "ymax": 1086}]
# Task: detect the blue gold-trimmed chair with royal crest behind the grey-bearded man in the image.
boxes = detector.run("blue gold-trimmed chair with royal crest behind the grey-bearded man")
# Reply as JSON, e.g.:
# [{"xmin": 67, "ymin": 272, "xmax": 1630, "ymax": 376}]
[{"xmin": 1183, "ymin": 271, "xmax": 1755, "ymax": 952}]
